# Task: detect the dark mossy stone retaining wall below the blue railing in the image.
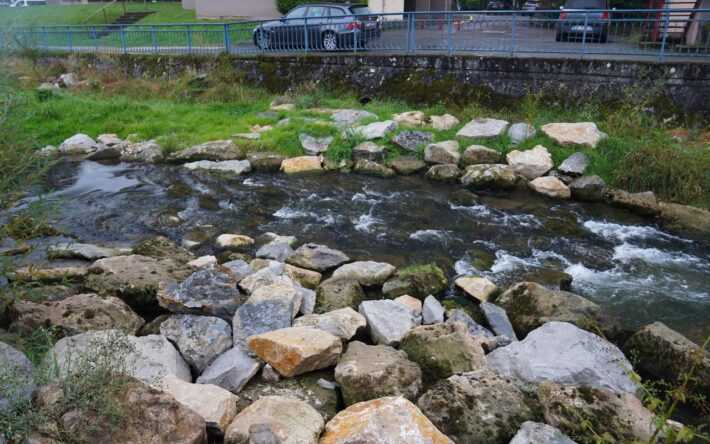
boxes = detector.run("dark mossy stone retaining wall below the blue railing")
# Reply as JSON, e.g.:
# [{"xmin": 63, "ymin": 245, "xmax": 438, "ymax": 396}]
[{"xmin": 43, "ymin": 54, "xmax": 710, "ymax": 116}]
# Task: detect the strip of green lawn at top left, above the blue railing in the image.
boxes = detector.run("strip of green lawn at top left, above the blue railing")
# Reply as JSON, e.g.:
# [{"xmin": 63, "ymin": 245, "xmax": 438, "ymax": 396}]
[{"xmin": 0, "ymin": 2, "xmax": 204, "ymax": 27}]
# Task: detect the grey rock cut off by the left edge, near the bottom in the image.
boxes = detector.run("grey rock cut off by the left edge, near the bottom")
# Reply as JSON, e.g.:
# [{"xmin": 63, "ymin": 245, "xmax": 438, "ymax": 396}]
[{"xmin": 0, "ymin": 341, "xmax": 37, "ymax": 412}]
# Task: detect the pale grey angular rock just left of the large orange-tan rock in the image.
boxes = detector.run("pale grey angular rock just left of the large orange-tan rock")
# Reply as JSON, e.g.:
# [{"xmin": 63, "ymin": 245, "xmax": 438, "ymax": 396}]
[{"xmin": 197, "ymin": 345, "xmax": 260, "ymax": 393}]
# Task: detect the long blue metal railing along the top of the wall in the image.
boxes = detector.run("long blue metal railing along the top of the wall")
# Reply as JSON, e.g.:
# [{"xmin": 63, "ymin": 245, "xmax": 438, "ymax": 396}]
[{"xmin": 0, "ymin": 9, "xmax": 710, "ymax": 61}]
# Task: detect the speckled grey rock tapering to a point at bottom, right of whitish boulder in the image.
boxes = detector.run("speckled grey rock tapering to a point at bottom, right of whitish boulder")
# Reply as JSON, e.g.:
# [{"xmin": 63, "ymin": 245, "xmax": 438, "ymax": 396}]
[{"xmin": 160, "ymin": 314, "xmax": 232, "ymax": 374}]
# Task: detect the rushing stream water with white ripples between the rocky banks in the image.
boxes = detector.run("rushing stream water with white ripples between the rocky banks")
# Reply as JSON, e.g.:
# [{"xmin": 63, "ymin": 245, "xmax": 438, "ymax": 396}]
[{"xmin": 26, "ymin": 162, "xmax": 710, "ymax": 341}]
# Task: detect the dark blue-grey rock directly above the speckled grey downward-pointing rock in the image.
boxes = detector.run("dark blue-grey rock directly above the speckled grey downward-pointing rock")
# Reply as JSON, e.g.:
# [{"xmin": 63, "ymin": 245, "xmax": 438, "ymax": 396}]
[{"xmin": 157, "ymin": 265, "xmax": 241, "ymax": 319}]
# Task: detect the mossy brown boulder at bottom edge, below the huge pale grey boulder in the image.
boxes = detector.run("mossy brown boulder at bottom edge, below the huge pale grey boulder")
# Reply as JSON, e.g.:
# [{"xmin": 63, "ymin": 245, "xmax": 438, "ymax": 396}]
[{"xmin": 536, "ymin": 381, "xmax": 656, "ymax": 442}]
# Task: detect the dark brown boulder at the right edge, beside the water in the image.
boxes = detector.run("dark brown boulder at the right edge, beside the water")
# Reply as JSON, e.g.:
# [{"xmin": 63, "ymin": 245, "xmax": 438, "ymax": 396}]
[{"xmin": 624, "ymin": 322, "xmax": 710, "ymax": 393}]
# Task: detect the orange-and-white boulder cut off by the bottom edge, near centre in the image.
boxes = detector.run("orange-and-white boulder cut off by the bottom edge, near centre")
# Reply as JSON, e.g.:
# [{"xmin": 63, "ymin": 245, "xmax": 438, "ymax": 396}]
[{"xmin": 320, "ymin": 396, "xmax": 453, "ymax": 444}]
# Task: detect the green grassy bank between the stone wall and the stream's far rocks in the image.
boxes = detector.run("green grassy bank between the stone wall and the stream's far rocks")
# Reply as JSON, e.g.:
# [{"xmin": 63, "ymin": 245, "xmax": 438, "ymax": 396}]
[{"xmin": 2, "ymin": 56, "xmax": 710, "ymax": 207}]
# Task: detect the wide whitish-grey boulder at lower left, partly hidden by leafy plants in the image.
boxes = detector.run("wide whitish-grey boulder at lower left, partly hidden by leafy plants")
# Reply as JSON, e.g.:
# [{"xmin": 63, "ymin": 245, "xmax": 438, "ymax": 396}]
[{"xmin": 46, "ymin": 330, "xmax": 192, "ymax": 383}]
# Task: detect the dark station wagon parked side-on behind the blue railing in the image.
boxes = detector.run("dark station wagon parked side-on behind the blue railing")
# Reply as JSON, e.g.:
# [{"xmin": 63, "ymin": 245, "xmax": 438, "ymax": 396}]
[{"xmin": 253, "ymin": 3, "xmax": 382, "ymax": 51}]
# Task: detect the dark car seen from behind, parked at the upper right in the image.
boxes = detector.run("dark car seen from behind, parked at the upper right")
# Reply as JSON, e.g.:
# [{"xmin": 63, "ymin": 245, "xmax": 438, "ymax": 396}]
[{"xmin": 555, "ymin": 0, "xmax": 611, "ymax": 43}]
